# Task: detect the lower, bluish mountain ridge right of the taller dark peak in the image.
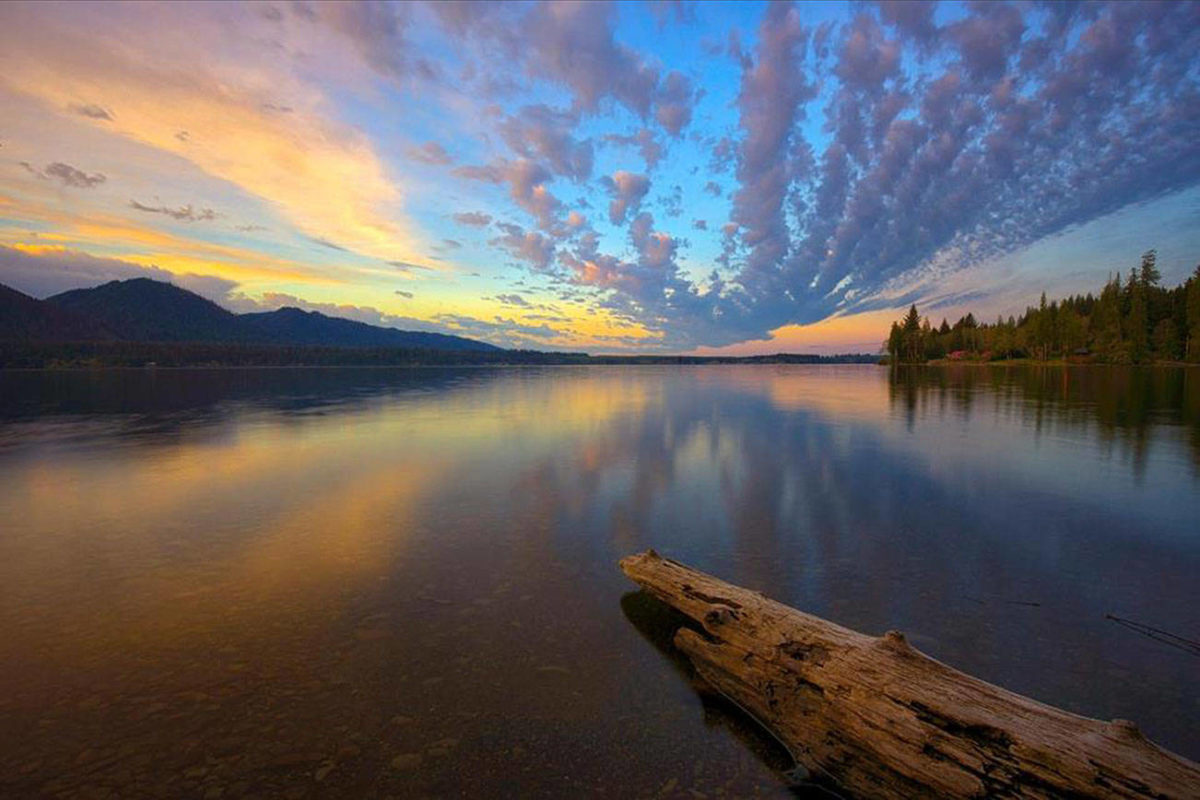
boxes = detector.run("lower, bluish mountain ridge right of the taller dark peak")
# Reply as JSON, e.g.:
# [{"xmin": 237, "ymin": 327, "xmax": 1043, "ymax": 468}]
[{"xmin": 239, "ymin": 307, "xmax": 500, "ymax": 350}]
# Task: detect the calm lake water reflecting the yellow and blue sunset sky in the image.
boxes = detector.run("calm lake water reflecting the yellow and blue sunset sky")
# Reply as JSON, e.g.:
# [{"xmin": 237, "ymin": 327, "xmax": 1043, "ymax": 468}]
[{"xmin": 0, "ymin": 366, "xmax": 1200, "ymax": 798}]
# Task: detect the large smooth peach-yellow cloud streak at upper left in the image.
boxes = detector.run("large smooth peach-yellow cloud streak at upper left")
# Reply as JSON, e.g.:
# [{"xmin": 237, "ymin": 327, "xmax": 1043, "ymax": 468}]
[{"xmin": 0, "ymin": 4, "xmax": 424, "ymax": 266}]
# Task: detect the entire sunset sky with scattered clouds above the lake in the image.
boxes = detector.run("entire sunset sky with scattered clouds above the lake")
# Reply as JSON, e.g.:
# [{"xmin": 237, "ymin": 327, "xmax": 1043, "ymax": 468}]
[{"xmin": 0, "ymin": 1, "xmax": 1200, "ymax": 355}]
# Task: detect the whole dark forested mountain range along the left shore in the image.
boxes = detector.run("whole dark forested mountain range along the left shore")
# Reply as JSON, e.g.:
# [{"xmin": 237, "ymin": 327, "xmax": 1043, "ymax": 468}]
[{"xmin": 0, "ymin": 278, "xmax": 500, "ymax": 353}]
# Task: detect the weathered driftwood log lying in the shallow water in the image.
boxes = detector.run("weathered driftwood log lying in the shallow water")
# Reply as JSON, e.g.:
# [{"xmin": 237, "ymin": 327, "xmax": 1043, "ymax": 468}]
[{"xmin": 620, "ymin": 551, "xmax": 1200, "ymax": 798}]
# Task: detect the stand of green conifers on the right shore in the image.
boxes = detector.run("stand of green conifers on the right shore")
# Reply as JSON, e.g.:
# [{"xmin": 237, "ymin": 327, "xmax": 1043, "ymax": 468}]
[{"xmin": 884, "ymin": 249, "xmax": 1200, "ymax": 363}]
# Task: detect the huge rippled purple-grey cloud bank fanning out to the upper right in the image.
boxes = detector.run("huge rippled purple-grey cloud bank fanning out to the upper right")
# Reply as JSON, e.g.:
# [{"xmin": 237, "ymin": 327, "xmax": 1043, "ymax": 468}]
[{"xmin": 564, "ymin": 2, "xmax": 1200, "ymax": 343}]
